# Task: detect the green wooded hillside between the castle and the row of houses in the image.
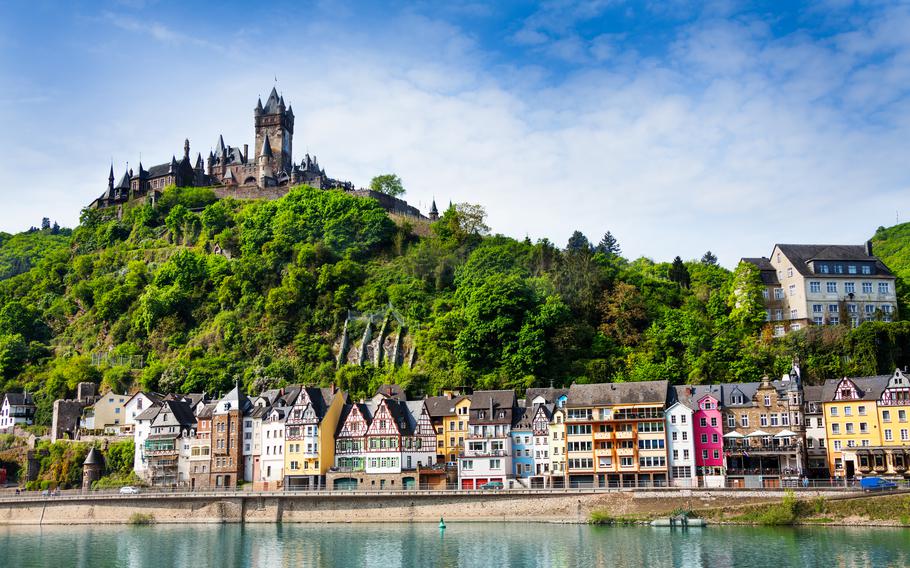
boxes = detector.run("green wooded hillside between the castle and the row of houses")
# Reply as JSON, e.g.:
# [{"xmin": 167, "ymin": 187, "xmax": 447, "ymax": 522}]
[{"xmin": 0, "ymin": 187, "xmax": 910, "ymax": 422}]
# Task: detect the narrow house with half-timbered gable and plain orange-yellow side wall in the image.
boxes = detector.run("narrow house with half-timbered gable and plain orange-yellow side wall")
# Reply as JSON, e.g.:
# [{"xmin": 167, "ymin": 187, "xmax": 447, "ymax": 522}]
[{"xmin": 284, "ymin": 386, "xmax": 347, "ymax": 489}]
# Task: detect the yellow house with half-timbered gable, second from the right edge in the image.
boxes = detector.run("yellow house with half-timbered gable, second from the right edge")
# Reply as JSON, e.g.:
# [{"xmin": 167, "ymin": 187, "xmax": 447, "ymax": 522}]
[{"xmin": 822, "ymin": 375, "xmax": 891, "ymax": 479}]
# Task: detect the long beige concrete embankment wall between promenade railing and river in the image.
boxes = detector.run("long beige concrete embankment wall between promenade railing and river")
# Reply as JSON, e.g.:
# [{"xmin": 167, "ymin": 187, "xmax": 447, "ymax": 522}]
[{"xmin": 0, "ymin": 490, "xmax": 856, "ymax": 525}]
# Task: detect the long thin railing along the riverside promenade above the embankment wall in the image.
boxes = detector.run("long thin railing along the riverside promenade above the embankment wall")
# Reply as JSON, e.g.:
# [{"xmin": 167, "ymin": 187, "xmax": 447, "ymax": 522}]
[{"xmin": 0, "ymin": 480, "xmax": 884, "ymax": 504}]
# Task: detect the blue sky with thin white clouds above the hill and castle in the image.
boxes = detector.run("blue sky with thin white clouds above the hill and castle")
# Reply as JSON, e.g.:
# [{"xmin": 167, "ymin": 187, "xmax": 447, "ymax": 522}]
[{"xmin": 0, "ymin": 0, "xmax": 910, "ymax": 266}]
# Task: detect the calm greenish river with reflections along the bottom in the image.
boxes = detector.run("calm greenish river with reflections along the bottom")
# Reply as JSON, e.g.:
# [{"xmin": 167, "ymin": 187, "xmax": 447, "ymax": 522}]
[{"xmin": 0, "ymin": 523, "xmax": 910, "ymax": 568}]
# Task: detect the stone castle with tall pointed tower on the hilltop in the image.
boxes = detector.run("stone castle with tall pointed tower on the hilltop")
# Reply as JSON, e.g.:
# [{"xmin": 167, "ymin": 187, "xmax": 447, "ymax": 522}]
[{"xmin": 89, "ymin": 87, "xmax": 438, "ymax": 220}]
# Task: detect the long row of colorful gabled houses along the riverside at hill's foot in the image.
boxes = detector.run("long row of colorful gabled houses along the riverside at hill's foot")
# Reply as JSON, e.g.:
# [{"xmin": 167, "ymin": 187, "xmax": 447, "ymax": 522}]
[{"xmin": 5, "ymin": 367, "xmax": 910, "ymax": 490}]
